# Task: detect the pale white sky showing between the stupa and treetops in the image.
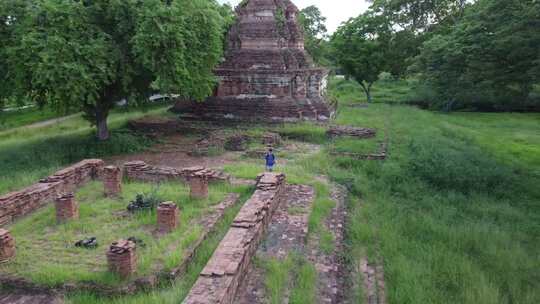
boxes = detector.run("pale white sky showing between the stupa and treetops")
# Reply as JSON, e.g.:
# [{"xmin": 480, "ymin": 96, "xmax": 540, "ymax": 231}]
[{"xmin": 218, "ymin": 0, "xmax": 369, "ymax": 33}]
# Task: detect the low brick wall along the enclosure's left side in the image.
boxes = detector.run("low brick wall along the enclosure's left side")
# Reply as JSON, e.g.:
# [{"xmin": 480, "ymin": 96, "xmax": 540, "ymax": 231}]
[{"xmin": 0, "ymin": 159, "xmax": 104, "ymax": 226}]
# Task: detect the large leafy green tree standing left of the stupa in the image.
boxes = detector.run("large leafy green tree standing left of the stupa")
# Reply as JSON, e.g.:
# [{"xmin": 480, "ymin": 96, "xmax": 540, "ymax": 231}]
[{"xmin": 2, "ymin": 0, "xmax": 224, "ymax": 140}]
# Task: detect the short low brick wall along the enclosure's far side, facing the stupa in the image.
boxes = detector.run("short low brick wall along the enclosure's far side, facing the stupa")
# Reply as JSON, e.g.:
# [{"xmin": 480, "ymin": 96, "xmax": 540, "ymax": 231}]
[{"xmin": 124, "ymin": 161, "xmax": 229, "ymax": 183}]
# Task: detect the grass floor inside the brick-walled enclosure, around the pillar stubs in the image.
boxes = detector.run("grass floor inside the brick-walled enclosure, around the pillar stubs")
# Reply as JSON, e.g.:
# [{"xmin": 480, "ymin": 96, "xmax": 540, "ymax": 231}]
[{"xmin": 0, "ymin": 182, "xmax": 245, "ymax": 286}]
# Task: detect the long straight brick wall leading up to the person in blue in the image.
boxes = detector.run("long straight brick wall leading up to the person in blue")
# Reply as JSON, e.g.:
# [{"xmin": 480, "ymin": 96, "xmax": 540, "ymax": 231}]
[{"xmin": 183, "ymin": 173, "xmax": 285, "ymax": 304}]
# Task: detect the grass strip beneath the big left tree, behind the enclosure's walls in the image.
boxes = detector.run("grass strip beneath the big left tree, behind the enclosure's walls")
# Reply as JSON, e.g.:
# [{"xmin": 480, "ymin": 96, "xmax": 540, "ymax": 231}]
[{"xmin": 0, "ymin": 106, "xmax": 173, "ymax": 193}]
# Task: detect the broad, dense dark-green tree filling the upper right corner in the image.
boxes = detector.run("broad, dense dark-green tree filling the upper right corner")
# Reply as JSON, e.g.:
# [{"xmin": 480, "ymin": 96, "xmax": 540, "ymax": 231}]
[{"xmin": 415, "ymin": 0, "xmax": 540, "ymax": 110}]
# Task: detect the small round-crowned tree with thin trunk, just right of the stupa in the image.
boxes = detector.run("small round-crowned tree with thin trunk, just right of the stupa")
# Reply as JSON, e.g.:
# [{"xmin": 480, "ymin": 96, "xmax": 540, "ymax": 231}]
[{"xmin": 331, "ymin": 11, "xmax": 392, "ymax": 102}]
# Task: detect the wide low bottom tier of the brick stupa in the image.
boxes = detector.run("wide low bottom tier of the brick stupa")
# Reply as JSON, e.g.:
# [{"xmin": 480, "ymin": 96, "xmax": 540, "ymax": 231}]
[{"xmin": 171, "ymin": 97, "xmax": 335, "ymax": 123}]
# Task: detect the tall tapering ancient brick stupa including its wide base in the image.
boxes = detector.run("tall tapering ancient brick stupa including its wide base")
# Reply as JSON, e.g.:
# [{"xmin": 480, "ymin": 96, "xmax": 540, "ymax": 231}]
[{"xmin": 173, "ymin": 0, "xmax": 332, "ymax": 121}]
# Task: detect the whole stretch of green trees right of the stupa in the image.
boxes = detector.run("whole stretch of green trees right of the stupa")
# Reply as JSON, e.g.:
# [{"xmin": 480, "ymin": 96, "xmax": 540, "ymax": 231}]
[{"xmin": 331, "ymin": 0, "xmax": 540, "ymax": 111}]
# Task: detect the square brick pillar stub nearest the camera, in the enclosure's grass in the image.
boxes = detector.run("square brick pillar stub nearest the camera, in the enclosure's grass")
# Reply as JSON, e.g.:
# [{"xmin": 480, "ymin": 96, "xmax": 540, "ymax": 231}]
[{"xmin": 107, "ymin": 240, "xmax": 137, "ymax": 278}]
